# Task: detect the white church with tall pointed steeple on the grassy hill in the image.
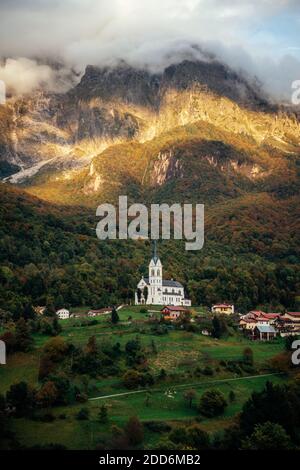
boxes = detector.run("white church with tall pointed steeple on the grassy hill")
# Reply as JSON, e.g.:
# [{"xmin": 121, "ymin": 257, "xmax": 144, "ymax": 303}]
[{"xmin": 135, "ymin": 243, "xmax": 191, "ymax": 307}]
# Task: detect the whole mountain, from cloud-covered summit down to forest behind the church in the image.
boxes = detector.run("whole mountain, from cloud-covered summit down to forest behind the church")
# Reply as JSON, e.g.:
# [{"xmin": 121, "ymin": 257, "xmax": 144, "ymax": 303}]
[{"xmin": 0, "ymin": 58, "xmax": 300, "ymax": 310}]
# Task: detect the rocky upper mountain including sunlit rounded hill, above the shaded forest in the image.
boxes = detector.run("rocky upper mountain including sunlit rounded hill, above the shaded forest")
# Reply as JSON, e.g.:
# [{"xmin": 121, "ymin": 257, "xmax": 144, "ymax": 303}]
[{"xmin": 0, "ymin": 60, "xmax": 300, "ymax": 204}]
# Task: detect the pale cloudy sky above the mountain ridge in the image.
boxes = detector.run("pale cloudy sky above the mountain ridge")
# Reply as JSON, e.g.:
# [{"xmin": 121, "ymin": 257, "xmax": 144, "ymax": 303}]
[{"xmin": 0, "ymin": 0, "xmax": 300, "ymax": 96}]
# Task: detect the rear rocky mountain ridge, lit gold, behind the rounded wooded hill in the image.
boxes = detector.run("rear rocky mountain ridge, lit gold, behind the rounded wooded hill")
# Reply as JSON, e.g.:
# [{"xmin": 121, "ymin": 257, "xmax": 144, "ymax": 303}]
[{"xmin": 0, "ymin": 61, "xmax": 298, "ymax": 191}]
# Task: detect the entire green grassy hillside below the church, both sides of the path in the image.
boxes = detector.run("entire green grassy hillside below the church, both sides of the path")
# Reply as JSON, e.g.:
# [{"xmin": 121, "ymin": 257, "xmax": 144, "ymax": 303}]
[{"xmin": 0, "ymin": 307, "xmax": 286, "ymax": 449}]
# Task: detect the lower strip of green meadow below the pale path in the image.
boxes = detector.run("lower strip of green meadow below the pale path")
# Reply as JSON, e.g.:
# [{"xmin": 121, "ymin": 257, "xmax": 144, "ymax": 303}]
[{"xmin": 6, "ymin": 375, "xmax": 284, "ymax": 449}]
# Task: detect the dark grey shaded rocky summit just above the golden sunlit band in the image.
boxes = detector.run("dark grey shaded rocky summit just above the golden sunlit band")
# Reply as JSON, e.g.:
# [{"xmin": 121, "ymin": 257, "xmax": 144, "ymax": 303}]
[{"xmin": 70, "ymin": 59, "xmax": 271, "ymax": 111}]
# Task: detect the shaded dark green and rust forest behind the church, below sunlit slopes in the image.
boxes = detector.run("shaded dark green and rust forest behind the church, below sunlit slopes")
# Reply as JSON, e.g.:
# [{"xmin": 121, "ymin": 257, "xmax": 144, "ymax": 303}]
[{"xmin": 0, "ymin": 184, "xmax": 299, "ymax": 318}]
